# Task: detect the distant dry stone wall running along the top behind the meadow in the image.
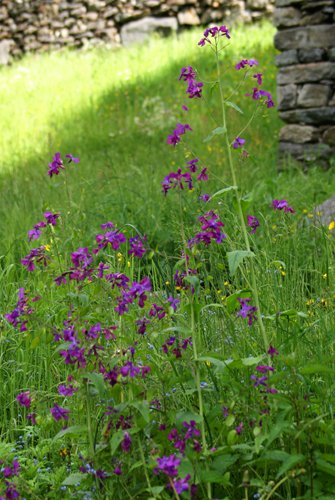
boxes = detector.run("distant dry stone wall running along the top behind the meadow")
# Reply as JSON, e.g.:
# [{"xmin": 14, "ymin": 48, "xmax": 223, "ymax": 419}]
[{"xmin": 0, "ymin": 0, "xmax": 274, "ymax": 60}]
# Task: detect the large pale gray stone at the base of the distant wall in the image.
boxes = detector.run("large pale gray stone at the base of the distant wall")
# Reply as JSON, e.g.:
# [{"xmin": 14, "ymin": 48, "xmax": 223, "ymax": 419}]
[{"xmin": 121, "ymin": 17, "xmax": 178, "ymax": 46}]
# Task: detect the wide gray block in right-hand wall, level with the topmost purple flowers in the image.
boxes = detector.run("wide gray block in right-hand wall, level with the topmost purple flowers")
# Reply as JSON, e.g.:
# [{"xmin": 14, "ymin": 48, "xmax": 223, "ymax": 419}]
[{"xmin": 274, "ymin": 24, "xmax": 335, "ymax": 50}]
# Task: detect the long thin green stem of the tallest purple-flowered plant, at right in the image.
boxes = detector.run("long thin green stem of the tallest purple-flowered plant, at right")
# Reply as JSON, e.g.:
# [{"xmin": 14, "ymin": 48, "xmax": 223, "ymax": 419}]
[{"xmin": 216, "ymin": 47, "xmax": 271, "ymax": 365}]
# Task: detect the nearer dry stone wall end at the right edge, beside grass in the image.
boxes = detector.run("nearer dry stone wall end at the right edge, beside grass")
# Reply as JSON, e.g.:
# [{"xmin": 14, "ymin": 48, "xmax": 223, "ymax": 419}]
[{"xmin": 273, "ymin": 0, "xmax": 335, "ymax": 160}]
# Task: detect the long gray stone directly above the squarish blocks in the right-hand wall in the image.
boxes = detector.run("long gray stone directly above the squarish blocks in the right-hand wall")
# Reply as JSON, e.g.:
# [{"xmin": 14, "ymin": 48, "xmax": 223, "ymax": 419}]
[{"xmin": 277, "ymin": 62, "xmax": 335, "ymax": 85}]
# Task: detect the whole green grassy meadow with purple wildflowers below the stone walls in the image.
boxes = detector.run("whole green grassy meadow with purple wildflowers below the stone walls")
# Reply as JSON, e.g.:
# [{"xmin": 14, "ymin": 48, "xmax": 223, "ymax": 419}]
[{"xmin": 0, "ymin": 23, "xmax": 335, "ymax": 500}]
